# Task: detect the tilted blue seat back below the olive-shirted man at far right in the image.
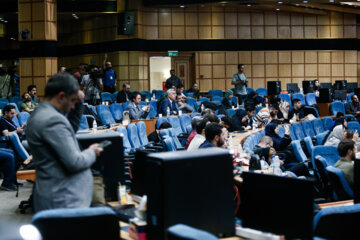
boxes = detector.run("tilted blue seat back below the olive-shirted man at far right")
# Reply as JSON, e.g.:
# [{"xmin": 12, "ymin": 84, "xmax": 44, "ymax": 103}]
[{"xmin": 326, "ymin": 166, "xmax": 354, "ymax": 201}]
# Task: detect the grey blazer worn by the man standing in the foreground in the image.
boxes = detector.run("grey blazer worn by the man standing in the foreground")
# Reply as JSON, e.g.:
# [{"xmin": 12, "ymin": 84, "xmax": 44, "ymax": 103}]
[{"xmin": 26, "ymin": 102, "xmax": 96, "ymax": 211}]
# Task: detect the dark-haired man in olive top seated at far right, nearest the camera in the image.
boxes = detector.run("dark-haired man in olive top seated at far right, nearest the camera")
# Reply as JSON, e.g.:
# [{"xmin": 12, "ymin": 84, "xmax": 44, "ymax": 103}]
[{"xmin": 334, "ymin": 139, "xmax": 355, "ymax": 187}]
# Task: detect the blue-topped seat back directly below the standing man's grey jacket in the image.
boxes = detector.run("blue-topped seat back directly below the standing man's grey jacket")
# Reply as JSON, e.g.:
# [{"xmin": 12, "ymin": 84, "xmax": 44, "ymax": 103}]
[{"xmin": 32, "ymin": 207, "xmax": 120, "ymax": 240}]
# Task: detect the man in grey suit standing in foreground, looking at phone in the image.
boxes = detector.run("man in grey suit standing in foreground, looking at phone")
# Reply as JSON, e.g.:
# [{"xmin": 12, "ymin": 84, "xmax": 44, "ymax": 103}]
[{"xmin": 26, "ymin": 73, "xmax": 103, "ymax": 212}]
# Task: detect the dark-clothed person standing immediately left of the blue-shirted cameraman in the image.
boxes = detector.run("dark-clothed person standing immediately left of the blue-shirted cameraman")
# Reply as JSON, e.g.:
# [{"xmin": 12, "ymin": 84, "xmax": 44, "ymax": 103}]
[{"xmin": 81, "ymin": 66, "xmax": 103, "ymax": 105}]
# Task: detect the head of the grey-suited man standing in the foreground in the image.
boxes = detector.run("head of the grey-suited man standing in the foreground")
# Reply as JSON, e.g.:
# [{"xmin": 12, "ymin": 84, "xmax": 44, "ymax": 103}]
[{"xmin": 45, "ymin": 73, "xmax": 80, "ymax": 113}]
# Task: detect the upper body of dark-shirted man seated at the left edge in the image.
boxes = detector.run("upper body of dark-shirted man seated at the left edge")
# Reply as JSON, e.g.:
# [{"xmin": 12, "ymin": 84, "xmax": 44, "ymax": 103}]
[{"xmin": 0, "ymin": 105, "xmax": 26, "ymax": 136}]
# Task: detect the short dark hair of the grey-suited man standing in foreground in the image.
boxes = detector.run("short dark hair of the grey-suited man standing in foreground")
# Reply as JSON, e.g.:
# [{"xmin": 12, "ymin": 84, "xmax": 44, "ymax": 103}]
[{"xmin": 45, "ymin": 73, "xmax": 80, "ymax": 98}]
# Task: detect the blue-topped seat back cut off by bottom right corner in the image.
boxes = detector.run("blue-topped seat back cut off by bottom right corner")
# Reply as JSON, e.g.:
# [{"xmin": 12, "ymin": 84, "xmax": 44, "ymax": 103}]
[{"xmin": 313, "ymin": 204, "xmax": 360, "ymax": 239}]
